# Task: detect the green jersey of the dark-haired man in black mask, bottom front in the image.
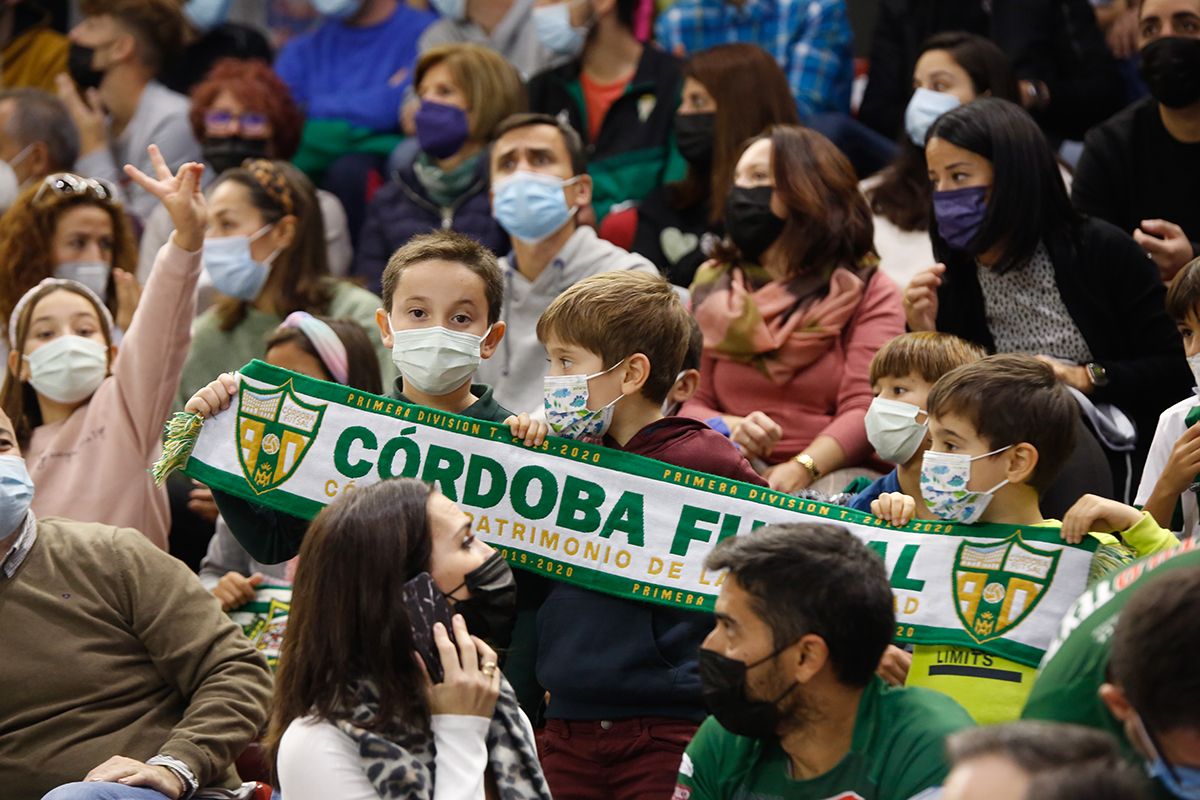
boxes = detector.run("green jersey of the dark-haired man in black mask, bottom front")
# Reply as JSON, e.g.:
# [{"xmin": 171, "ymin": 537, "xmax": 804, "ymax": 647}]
[{"xmin": 673, "ymin": 678, "xmax": 973, "ymax": 800}]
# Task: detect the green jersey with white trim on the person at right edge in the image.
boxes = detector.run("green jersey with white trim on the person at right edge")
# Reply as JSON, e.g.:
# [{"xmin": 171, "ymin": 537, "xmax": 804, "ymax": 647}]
[{"xmin": 1021, "ymin": 540, "xmax": 1200, "ymax": 763}]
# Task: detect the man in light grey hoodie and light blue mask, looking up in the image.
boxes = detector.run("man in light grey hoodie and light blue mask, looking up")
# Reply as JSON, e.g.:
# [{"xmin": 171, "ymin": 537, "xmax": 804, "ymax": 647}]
[{"xmin": 476, "ymin": 114, "xmax": 658, "ymax": 413}]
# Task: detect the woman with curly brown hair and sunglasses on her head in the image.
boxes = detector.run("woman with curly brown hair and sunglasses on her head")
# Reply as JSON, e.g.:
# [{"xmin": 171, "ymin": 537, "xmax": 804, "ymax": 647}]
[{"xmin": 0, "ymin": 173, "xmax": 142, "ymax": 347}]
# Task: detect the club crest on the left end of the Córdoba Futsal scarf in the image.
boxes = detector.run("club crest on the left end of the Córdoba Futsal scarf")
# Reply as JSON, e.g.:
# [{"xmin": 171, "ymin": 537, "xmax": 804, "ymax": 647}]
[{"xmin": 238, "ymin": 380, "xmax": 325, "ymax": 494}]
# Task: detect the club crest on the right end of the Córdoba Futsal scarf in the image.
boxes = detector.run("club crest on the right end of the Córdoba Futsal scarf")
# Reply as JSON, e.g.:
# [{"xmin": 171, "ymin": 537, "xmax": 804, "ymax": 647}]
[{"xmin": 954, "ymin": 533, "xmax": 1062, "ymax": 644}]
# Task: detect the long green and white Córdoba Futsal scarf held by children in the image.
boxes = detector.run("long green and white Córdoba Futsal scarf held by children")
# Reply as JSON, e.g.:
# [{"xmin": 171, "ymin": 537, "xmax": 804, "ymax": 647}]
[{"xmin": 155, "ymin": 361, "xmax": 1097, "ymax": 666}]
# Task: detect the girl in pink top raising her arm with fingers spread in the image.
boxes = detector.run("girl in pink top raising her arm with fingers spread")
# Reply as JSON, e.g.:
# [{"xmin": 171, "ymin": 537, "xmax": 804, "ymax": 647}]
[{"xmin": 2, "ymin": 145, "xmax": 206, "ymax": 548}]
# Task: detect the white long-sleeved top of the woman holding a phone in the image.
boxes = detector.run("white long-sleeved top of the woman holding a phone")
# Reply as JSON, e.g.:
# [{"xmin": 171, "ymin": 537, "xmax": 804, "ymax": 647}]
[{"xmin": 278, "ymin": 712, "xmax": 533, "ymax": 800}]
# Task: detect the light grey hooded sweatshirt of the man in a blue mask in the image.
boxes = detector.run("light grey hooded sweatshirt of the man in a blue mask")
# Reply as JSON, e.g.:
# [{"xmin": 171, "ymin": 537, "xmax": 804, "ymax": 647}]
[{"xmin": 475, "ymin": 227, "xmax": 659, "ymax": 411}]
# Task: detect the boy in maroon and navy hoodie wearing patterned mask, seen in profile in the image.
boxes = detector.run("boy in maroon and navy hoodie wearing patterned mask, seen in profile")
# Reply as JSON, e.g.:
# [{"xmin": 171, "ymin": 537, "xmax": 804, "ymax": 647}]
[{"xmin": 514, "ymin": 272, "xmax": 766, "ymax": 800}]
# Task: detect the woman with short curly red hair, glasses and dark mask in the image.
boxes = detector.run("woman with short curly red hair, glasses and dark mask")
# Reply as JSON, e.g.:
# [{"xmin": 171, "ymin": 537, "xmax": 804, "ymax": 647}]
[{"xmin": 138, "ymin": 59, "xmax": 354, "ymax": 291}]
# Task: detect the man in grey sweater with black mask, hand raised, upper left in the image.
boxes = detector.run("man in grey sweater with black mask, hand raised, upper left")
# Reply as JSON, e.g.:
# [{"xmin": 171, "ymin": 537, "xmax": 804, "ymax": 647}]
[{"xmin": 58, "ymin": 0, "xmax": 200, "ymax": 221}]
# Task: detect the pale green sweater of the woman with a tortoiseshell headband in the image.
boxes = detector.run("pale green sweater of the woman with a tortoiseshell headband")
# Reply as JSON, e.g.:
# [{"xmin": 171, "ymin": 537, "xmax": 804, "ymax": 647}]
[{"xmin": 175, "ymin": 281, "xmax": 396, "ymax": 410}]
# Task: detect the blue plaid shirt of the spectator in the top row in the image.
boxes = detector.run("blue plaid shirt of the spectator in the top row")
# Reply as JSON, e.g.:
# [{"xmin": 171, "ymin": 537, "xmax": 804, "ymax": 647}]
[{"xmin": 654, "ymin": 0, "xmax": 854, "ymax": 119}]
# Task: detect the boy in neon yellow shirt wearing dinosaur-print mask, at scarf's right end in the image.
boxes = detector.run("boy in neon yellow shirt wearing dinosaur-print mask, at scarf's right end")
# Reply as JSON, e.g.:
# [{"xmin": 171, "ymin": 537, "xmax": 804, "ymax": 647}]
[{"xmin": 872, "ymin": 354, "xmax": 1177, "ymax": 724}]
